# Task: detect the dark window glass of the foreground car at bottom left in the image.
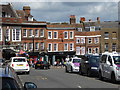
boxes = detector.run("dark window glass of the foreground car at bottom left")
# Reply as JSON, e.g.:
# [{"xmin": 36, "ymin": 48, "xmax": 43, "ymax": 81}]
[{"xmin": 0, "ymin": 77, "xmax": 20, "ymax": 90}]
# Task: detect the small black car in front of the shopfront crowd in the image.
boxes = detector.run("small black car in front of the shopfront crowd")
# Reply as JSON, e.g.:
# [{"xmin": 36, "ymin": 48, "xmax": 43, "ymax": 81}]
[{"xmin": 35, "ymin": 61, "xmax": 50, "ymax": 69}]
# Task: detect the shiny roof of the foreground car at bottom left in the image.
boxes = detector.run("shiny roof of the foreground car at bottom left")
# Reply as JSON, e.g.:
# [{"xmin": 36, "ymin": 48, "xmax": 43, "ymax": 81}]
[{"xmin": 0, "ymin": 66, "xmax": 15, "ymax": 79}]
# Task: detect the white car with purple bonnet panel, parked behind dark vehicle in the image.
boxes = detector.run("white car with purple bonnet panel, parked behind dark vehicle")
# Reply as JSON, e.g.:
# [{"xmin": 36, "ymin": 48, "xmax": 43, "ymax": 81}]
[{"xmin": 65, "ymin": 57, "xmax": 81, "ymax": 72}]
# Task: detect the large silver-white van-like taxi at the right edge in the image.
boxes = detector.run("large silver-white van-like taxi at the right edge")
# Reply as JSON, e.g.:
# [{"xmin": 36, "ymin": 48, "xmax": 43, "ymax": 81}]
[{"xmin": 99, "ymin": 52, "xmax": 120, "ymax": 83}]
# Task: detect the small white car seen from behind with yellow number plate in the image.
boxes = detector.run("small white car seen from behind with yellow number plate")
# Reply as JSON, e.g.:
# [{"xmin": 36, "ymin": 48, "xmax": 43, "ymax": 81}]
[{"xmin": 10, "ymin": 57, "xmax": 30, "ymax": 74}]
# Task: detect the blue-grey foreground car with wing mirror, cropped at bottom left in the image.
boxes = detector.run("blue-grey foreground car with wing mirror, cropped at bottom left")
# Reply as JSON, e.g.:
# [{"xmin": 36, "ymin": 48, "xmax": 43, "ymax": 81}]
[{"xmin": 0, "ymin": 66, "xmax": 37, "ymax": 90}]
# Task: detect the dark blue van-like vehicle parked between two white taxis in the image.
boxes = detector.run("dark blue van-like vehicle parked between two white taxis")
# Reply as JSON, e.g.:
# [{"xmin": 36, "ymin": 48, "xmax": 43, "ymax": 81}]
[{"xmin": 79, "ymin": 55, "xmax": 100, "ymax": 76}]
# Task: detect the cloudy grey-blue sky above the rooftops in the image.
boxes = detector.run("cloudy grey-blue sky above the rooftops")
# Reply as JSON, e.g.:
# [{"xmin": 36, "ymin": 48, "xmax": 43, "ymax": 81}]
[{"xmin": 13, "ymin": 2, "xmax": 118, "ymax": 22}]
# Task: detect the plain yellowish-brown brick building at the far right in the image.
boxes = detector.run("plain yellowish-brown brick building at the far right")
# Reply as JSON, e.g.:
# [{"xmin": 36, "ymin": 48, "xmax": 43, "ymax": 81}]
[{"xmin": 101, "ymin": 21, "xmax": 120, "ymax": 53}]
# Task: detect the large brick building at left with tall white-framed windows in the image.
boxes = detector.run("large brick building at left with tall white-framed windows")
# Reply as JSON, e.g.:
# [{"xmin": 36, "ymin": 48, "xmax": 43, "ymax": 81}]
[{"xmin": 0, "ymin": 4, "xmax": 46, "ymax": 52}]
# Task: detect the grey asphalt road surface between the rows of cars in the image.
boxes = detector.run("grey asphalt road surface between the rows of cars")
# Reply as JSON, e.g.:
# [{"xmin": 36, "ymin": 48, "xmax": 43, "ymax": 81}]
[{"xmin": 19, "ymin": 68, "xmax": 120, "ymax": 88}]
